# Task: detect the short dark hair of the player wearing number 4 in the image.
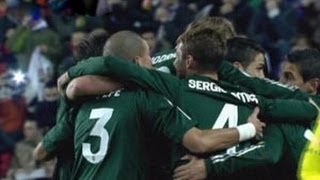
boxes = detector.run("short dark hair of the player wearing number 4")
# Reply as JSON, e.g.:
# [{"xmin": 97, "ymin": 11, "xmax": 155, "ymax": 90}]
[{"xmin": 178, "ymin": 28, "xmax": 226, "ymax": 70}]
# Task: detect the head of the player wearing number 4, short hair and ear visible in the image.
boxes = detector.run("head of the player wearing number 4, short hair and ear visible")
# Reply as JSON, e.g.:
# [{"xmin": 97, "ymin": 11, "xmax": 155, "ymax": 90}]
[{"xmin": 174, "ymin": 28, "xmax": 226, "ymax": 76}]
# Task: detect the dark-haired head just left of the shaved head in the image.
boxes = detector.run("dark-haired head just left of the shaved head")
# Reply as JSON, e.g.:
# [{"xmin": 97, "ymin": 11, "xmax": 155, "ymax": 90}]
[{"xmin": 75, "ymin": 29, "xmax": 109, "ymax": 60}]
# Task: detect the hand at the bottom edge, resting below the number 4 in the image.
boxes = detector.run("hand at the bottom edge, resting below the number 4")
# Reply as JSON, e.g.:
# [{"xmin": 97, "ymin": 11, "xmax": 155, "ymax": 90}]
[{"xmin": 173, "ymin": 155, "xmax": 207, "ymax": 180}]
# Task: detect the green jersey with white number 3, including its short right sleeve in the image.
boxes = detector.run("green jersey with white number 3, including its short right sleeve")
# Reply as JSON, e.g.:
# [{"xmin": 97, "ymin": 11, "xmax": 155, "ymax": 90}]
[{"xmin": 52, "ymin": 90, "xmax": 194, "ymax": 180}]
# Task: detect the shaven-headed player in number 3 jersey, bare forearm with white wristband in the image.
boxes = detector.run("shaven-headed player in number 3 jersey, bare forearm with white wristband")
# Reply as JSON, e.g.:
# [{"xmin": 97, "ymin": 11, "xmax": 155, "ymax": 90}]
[{"xmin": 34, "ymin": 32, "xmax": 264, "ymax": 179}]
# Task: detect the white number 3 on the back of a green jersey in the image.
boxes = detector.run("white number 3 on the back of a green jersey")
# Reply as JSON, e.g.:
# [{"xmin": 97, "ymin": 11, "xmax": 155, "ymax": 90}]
[{"xmin": 82, "ymin": 108, "xmax": 113, "ymax": 164}]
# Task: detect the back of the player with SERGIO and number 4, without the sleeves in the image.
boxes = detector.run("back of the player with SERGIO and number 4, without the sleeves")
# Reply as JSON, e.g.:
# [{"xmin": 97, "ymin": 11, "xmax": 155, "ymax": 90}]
[{"xmin": 179, "ymin": 76, "xmax": 258, "ymax": 158}]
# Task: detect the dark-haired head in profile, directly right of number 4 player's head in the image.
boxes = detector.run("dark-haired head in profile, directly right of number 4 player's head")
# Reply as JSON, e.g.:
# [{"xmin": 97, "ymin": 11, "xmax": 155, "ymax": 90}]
[{"xmin": 225, "ymin": 37, "xmax": 265, "ymax": 78}]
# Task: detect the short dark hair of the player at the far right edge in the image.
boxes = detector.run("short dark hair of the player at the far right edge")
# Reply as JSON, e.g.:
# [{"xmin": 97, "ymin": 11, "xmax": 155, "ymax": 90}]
[{"xmin": 287, "ymin": 49, "xmax": 320, "ymax": 81}]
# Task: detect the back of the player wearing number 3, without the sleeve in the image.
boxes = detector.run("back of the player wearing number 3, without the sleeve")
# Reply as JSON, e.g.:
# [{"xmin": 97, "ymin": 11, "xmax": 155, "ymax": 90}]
[{"xmin": 73, "ymin": 91, "xmax": 148, "ymax": 180}]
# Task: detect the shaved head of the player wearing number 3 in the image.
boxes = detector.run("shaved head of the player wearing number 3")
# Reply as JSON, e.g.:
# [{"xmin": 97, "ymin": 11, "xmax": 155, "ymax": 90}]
[{"xmin": 103, "ymin": 31, "xmax": 152, "ymax": 68}]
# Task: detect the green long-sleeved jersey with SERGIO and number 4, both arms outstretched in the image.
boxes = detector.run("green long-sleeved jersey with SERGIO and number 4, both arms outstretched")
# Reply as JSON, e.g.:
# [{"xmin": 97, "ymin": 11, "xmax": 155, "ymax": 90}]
[{"xmin": 69, "ymin": 58, "xmax": 317, "ymax": 177}]
